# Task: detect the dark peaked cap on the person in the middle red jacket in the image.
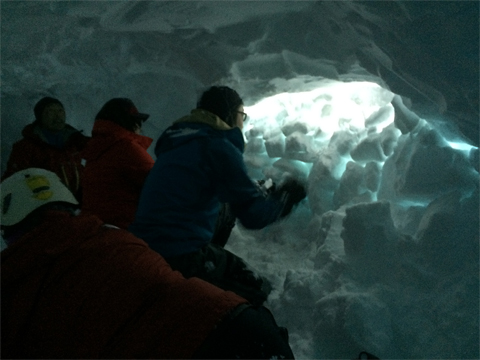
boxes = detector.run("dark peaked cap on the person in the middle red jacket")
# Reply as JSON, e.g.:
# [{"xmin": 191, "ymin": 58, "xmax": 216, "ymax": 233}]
[{"xmin": 95, "ymin": 98, "xmax": 150, "ymax": 131}]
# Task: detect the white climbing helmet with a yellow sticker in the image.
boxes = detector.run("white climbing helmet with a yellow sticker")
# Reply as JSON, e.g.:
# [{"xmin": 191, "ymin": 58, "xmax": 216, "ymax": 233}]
[{"xmin": 0, "ymin": 168, "xmax": 78, "ymax": 226}]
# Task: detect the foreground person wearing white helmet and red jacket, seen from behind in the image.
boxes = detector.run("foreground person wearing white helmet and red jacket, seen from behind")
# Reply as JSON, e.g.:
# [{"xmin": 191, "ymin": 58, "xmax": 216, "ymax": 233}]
[{"xmin": 1, "ymin": 168, "xmax": 293, "ymax": 359}]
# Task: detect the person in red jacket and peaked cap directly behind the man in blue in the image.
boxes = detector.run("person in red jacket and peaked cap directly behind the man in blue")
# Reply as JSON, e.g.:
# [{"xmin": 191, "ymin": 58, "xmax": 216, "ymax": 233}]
[{"xmin": 82, "ymin": 98, "xmax": 154, "ymax": 229}]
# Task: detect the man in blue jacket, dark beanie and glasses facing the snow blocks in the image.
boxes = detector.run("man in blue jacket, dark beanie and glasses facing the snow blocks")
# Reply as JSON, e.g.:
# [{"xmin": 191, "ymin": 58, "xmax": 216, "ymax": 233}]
[{"xmin": 129, "ymin": 86, "xmax": 306, "ymax": 304}]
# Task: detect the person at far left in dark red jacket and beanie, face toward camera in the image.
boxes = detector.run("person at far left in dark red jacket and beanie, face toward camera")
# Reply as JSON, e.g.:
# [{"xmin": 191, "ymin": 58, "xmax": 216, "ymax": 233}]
[{"xmin": 2, "ymin": 96, "xmax": 90, "ymax": 200}]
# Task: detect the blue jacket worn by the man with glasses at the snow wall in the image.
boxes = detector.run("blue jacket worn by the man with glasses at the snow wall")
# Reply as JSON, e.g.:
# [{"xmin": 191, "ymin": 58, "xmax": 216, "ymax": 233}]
[{"xmin": 129, "ymin": 109, "xmax": 283, "ymax": 257}]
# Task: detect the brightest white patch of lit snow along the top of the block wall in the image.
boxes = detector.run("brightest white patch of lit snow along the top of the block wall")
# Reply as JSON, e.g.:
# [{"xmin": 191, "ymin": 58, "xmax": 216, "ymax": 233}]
[{"xmin": 246, "ymin": 80, "xmax": 393, "ymax": 136}]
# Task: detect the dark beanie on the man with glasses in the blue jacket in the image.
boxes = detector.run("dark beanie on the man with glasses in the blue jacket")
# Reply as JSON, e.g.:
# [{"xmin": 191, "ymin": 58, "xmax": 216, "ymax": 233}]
[{"xmin": 197, "ymin": 86, "xmax": 243, "ymax": 126}]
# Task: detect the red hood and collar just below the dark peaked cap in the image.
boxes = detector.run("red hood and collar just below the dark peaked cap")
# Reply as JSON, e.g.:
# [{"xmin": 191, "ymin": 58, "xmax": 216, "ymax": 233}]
[{"xmin": 82, "ymin": 120, "xmax": 153, "ymax": 161}]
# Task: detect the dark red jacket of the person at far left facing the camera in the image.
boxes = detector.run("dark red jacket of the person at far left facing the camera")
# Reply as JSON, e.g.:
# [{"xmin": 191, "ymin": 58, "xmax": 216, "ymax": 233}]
[{"xmin": 2, "ymin": 124, "xmax": 90, "ymax": 200}]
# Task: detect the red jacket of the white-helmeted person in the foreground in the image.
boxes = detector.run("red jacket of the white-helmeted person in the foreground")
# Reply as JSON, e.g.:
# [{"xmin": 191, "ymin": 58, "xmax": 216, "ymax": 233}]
[{"xmin": 1, "ymin": 211, "xmax": 246, "ymax": 359}]
